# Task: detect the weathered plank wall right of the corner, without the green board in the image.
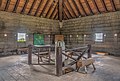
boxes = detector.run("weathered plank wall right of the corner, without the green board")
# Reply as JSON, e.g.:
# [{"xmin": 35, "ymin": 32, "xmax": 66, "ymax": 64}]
[{"xmin": 62, "ymin": 11, "xmax": 120, "ymax": 55}]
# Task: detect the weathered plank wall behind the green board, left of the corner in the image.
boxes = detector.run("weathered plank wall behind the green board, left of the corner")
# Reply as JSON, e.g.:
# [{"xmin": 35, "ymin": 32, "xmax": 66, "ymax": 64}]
[{"xmin": 0, "ymin": 11, "xmax": 59, "ymax": 51}]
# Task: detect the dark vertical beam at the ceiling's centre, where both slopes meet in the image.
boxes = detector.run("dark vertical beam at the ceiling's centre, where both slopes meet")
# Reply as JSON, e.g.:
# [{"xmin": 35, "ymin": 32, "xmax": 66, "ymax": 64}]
[{"xmin": 58, "ymin": 0, "xmax": 63, "ymax": 22}]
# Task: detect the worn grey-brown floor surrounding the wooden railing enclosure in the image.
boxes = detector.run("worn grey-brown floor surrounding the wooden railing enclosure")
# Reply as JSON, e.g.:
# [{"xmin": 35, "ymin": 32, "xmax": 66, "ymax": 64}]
[{"xmin": 0, "ymin": 55, "xmax": 120, "ymax": 81}]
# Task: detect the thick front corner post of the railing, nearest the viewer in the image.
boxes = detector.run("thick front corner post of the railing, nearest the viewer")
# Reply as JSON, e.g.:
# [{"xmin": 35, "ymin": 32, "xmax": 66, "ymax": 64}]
[{"xmin": 55, "ymin": 47, "xmax": 62, "ymax": 76}]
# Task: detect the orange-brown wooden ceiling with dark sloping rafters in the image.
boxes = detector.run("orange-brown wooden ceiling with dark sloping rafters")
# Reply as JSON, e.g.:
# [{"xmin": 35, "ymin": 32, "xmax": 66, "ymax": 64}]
[{"xmin": 0, "ymin": 0, "xmax": 120, "ymax": 20}]
